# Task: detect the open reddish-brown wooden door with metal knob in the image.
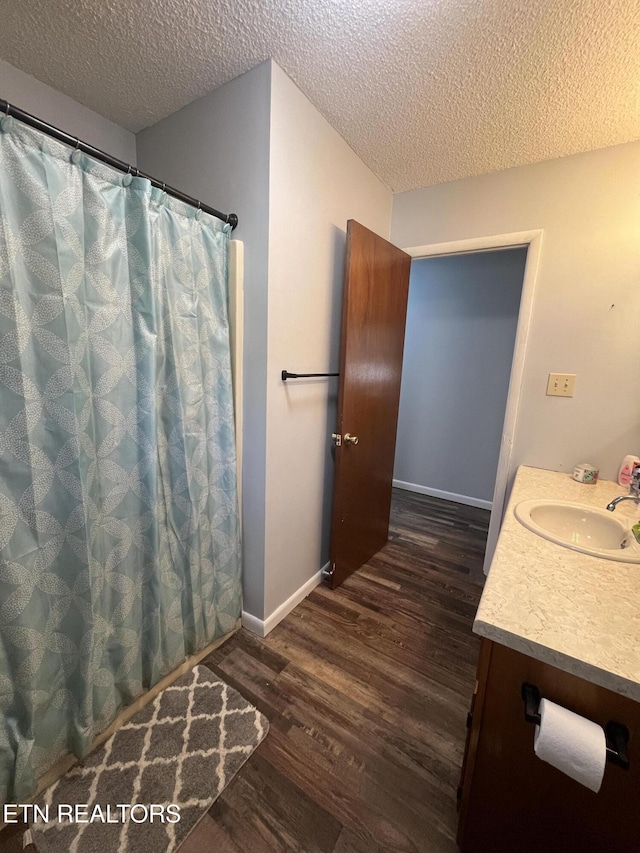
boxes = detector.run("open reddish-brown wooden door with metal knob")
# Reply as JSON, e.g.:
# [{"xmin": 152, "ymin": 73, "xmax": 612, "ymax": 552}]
[{"xmin": 330, "ymin": 219, "xmax": 411, "ymax": 587}]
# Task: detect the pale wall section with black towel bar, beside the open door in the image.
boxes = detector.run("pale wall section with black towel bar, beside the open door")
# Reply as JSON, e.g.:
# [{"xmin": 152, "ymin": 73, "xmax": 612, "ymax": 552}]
[{"xmin": 265, "ymin": 63, "xmax": 392, "ymax": 617}]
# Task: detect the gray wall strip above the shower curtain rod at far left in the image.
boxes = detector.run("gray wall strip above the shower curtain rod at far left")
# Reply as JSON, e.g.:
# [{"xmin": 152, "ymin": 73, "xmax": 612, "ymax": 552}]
[{"xmin": 0, "ymin": 59, "xmax": 136, "ymax": 164}]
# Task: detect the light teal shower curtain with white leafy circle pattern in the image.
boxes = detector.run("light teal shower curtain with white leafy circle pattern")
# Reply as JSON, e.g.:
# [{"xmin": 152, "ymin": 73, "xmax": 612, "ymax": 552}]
[{"xmin": 0, "ymin": 117, "xmax": 241, "ymax": 802}]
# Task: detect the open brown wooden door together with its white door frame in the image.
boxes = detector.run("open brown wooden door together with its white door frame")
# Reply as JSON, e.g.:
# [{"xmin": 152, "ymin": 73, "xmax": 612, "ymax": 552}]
[{"xmin": 324, "ymin": 220, "xmax": 542, "ymax": 588}]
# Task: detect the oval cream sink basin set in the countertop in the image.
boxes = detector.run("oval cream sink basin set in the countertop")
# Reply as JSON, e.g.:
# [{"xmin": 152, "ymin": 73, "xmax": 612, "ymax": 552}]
[{"xmin": 514, "ymin": 500, "xmax": 640, "ymax": 563}]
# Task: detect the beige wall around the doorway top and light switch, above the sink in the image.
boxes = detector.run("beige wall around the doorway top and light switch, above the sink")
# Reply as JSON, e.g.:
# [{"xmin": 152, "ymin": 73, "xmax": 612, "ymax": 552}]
[{"xmin": 391, "ymin": 142, "xmax": 640, "ymax": 479}]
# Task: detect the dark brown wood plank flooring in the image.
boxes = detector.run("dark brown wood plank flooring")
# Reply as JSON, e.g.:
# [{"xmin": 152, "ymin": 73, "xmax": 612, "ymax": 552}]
[{"xmin": 0, "ymin": 490, "xmax": 489, "ymax": 853}]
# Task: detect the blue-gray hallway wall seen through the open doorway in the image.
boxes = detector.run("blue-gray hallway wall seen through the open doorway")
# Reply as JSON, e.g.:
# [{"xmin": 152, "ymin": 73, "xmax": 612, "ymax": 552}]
[{"xmin": 394, "ymin": 248, "xmax": 527, "ymax": 501}]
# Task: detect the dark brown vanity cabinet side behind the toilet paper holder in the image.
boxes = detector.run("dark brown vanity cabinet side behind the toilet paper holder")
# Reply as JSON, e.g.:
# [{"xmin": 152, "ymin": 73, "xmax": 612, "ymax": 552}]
[{"xmin": 458, "ymin": 638, "xmax": 640, "ymax": 853}]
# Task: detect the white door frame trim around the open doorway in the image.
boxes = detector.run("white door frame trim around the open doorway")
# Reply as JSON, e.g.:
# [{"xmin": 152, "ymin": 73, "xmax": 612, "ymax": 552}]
[{"xmin": 405, "ymin": 231, "xmax": 542, "ymax": 574}]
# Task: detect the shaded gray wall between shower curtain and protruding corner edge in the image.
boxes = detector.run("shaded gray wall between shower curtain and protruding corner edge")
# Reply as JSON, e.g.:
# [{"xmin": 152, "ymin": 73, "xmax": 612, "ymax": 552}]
[{"xmin": 137, "ymin": 62, "xmax": 271, "ymax": 614}]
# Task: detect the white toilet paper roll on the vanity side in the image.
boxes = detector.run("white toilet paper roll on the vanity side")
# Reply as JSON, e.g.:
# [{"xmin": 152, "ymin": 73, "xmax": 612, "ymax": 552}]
[{"xmin": 533, "ymin": 699, "xmax": 607, "ymax": 793}]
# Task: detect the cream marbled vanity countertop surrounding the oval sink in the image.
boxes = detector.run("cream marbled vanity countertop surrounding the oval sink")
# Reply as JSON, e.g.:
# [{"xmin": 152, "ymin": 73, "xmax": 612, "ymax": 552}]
[{"xmin": 473, "ymin": 466, "xmax": 640, "ymax": 702}]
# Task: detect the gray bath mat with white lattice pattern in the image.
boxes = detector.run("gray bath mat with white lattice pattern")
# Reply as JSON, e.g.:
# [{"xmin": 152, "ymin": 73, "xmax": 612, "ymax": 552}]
[{"xmin": 30, "ymin": 666, "xmax": 269, "ymax": 853}]
